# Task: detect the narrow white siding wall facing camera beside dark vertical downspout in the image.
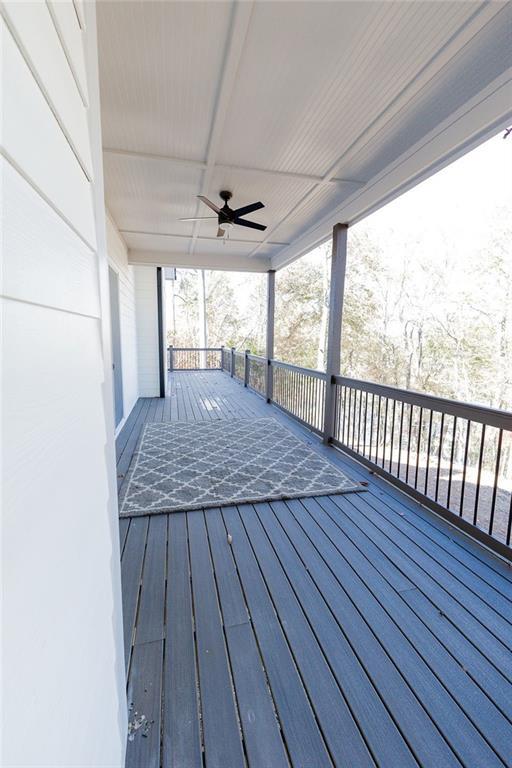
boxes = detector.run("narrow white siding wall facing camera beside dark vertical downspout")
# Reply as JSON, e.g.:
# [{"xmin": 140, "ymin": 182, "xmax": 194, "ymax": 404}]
[{"xmin": 134, "ymin": 266, "xmax": 160, "ymax": 397}]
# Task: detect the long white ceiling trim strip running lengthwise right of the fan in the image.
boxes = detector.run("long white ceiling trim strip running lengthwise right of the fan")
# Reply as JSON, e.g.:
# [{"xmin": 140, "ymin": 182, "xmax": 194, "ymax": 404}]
[{"xmin": 249, "ymin": 3, "xmax": 504, "ymax": 258}]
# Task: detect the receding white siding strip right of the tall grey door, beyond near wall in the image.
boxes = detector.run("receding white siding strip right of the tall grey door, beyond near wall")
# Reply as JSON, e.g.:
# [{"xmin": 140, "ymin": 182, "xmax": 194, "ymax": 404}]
[{"xmin": 107, "ymin": 216, "xmax": 139, "ymax": 432}]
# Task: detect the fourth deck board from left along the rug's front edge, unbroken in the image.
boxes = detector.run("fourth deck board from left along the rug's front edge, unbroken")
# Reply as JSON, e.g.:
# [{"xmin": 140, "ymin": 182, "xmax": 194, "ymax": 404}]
[{"xmin": 187, "ymin": 512, "xmax": 244, "ymax": 768}]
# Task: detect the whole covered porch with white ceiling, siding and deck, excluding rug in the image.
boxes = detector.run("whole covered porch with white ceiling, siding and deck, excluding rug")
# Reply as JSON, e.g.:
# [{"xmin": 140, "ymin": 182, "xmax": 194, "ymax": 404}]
[{"xmin": 4, "ymin": 0, "xmax": 512, "ymax": 768}]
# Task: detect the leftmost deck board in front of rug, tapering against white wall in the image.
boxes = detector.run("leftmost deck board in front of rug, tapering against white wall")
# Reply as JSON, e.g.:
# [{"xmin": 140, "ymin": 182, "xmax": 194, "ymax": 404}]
[{"xmin": 121, "ymin": 517, "xmax": 149, "ymax": 669}]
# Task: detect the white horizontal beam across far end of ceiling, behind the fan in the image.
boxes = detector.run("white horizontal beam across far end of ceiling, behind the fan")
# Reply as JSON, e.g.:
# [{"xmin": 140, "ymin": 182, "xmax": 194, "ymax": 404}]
[{"xmin": 128, "ymin": 249, "xmax": 271, "ymax": 272}]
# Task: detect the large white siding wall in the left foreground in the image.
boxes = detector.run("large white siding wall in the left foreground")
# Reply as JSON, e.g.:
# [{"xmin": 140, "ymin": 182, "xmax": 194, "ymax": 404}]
[{"xmin": 0, "ymin": 0, "xmax": 126, "ymax": 768}]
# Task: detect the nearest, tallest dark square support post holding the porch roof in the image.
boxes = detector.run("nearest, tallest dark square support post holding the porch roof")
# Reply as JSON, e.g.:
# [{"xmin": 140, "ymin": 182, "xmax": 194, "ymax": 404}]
[{"xmin": 323, "ymin": 224, "xmax": 348, "ymax": 444}]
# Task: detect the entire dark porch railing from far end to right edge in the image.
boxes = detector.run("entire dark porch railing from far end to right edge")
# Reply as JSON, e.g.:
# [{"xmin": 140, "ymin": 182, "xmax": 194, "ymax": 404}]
[{"xmin": 169, "ymin": 347, "xmax": 512, "ymax": 558}]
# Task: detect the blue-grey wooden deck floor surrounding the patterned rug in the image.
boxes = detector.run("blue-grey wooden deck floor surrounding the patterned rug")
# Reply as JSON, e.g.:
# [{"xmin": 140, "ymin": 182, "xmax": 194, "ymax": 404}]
[{"xmin": 117, "ymin": 372, "xmax": 512, "ymax": 768}]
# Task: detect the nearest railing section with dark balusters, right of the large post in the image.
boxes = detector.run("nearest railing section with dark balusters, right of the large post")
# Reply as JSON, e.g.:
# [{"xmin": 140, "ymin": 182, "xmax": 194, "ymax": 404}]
[{"xmin": 332, "ymin": 376, "xmax": 512, "ymax": 546}]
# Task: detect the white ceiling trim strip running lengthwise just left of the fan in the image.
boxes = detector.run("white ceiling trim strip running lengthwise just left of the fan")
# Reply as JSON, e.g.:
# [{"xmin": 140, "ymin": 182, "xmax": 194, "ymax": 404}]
[{"xmin": 189, "ymin": 0, "xmax": 254, "ymax": 253}]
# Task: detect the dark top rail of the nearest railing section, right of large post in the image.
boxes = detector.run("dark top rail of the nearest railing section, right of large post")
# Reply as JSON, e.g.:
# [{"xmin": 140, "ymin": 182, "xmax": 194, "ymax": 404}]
[{"xmin": 334, "ymin": 376, "xmax": 512, "ymax": 431}]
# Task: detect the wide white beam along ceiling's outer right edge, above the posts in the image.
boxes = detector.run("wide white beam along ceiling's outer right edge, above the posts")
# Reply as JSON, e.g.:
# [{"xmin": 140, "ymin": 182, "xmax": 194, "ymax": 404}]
[{"xmin": 272, "ymin": 69, "xmax": 512, "ymax": 269}]
